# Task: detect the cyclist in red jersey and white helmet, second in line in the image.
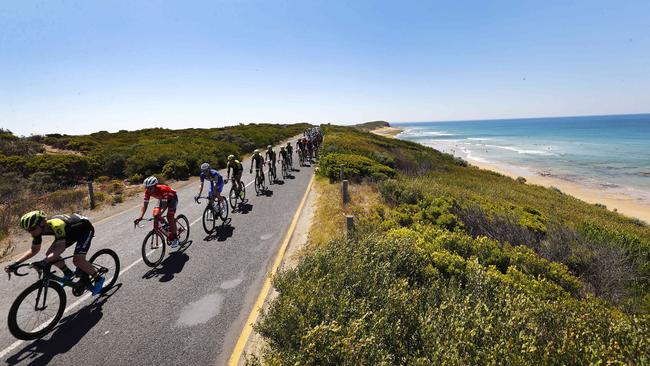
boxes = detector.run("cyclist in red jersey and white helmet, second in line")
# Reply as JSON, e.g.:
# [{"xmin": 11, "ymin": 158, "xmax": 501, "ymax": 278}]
[{"xmin": 133, "ymin": 176, "xmax": 180, "ymax": 248}]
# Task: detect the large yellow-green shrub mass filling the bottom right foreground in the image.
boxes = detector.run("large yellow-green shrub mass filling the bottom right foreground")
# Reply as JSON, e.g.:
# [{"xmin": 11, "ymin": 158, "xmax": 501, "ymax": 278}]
[{"xmin": 255, "ymin": 232, "xmax": 650, "ymax": 365}]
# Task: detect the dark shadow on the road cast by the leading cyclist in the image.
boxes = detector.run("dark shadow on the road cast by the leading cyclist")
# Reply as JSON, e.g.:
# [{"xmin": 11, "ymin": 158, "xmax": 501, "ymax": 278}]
[{"xmin": 7, "ymin": 283, "xmax": 122, "ymax": 365}]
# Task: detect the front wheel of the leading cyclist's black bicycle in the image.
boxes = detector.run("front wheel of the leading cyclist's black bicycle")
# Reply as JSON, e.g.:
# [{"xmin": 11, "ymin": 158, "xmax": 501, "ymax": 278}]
[{"xmin": 7, "ymin": 281, "xmax": 66, "ymax": 341}]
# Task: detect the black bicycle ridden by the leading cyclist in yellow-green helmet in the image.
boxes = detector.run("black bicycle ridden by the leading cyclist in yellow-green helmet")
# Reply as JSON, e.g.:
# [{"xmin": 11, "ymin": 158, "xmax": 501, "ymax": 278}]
[{"xmin": 7, "ymin": 248, "xmax": 120, "ymax": 341}]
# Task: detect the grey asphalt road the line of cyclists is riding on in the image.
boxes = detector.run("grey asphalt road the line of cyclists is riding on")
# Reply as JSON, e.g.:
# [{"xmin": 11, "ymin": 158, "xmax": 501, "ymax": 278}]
[{"xmin": 0, "ymin": 143, "xmax": 313, "ymax": 366}]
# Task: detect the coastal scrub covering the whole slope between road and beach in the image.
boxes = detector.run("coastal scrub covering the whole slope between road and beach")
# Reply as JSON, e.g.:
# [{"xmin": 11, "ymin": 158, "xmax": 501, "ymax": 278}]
[{"xmin": 251, "ymin": 125, "xmax": 650, "ymax": 365}]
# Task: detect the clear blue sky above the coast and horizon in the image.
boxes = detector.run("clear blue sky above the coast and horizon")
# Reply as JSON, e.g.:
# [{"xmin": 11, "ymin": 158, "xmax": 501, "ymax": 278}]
[{"xmin": 0, "ymin": 0, "xmax": 650, "ymax": 135}]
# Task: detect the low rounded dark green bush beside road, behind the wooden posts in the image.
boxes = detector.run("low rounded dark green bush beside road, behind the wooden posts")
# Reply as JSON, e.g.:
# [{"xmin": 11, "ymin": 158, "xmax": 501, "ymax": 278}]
[{"xmin": 319, "ymin": 153, "xmax": 395, "ymax": 181}]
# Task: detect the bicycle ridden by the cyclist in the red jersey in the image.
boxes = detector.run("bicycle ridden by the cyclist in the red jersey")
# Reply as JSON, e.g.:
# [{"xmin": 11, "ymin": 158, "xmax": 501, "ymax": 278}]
[{"xmin": 135, "ymin": 215, "xmax": 190, "ymax": 268}]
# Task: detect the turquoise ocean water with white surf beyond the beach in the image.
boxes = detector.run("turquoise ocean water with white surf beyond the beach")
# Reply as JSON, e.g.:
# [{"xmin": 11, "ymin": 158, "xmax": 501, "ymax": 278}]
[{"xmin": 391, "ymin": 114, "xmax": 650, "ymax": 203}]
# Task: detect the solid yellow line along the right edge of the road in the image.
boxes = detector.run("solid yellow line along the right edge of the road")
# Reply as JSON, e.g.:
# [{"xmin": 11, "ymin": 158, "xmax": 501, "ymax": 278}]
[{"xmin": 228, "ymin": 174, "xmax": 314, "ymax": 366}]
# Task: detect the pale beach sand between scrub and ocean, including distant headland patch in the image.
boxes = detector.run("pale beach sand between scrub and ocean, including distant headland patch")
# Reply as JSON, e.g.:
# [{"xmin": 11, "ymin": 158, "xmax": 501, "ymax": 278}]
[{"xmin": 372, "ymin": 127, "xmax": 650, "ymax": 223}]
